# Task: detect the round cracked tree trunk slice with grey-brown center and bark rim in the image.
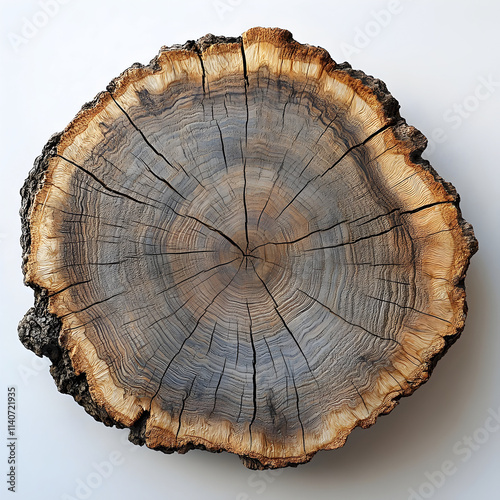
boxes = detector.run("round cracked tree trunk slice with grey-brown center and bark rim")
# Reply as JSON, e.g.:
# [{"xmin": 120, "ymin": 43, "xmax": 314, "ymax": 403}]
[{"xmin": 20, "ymin": 28, "xmax": 477, "ymax": 468}]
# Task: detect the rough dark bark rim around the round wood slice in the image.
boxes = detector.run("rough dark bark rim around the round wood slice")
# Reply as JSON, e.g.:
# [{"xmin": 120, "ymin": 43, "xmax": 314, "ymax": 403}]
[{"xmin": 18, "ymin": 30, "xmax": 478, "ymax": 470}]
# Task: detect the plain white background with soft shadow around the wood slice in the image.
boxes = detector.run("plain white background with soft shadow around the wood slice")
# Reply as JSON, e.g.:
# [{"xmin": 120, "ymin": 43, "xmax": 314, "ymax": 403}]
[{"xmin": 0, "ymin": 0, "xmax": 500, "ymax": 500}]
